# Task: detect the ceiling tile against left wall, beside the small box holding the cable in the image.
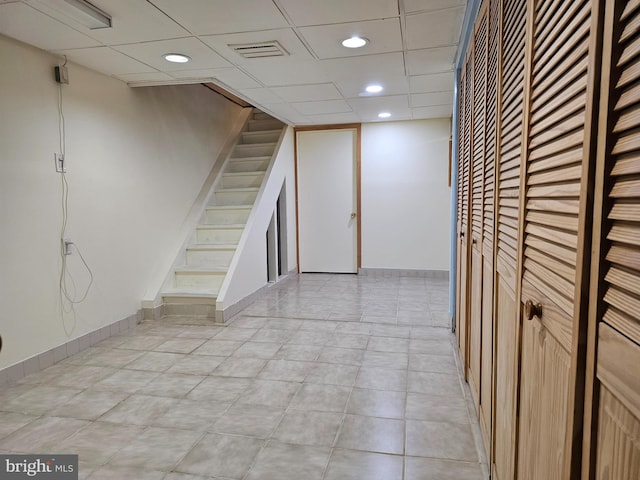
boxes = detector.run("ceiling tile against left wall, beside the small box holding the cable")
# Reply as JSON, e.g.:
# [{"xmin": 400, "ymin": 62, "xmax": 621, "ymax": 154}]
[{"xmin": 56, "ymin": 47, "xmax": 156, "ymax": 75}]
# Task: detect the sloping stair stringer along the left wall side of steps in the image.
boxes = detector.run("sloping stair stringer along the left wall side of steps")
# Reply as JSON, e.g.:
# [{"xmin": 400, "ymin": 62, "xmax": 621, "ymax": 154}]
[{"xmin": 142, "ymin": 108, "xmax": 253, "ymax": 310}]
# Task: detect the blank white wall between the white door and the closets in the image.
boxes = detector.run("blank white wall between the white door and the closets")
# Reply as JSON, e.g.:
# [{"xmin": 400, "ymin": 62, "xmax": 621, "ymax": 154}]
[{"xmin": 361, "ymin": 119, "xmax": 451, "ymax": 270}]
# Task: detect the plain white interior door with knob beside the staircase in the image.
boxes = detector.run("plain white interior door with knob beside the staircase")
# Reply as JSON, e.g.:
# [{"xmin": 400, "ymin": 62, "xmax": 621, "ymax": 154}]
[{"xmin": 297, "ymin": 129, "xmax": 358, "ymax": 273}]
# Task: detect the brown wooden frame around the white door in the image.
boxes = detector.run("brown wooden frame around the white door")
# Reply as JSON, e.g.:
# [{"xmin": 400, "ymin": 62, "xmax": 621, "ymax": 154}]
[{"xmin": 293, "ymin": 123, "xmax": 362, "ymax": 273}]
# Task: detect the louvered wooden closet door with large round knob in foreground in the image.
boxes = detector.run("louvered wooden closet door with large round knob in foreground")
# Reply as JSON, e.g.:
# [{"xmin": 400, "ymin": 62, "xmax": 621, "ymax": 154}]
[{"xmin": 517, "ymin": 0, "xmax": 600, "ymax": 480}]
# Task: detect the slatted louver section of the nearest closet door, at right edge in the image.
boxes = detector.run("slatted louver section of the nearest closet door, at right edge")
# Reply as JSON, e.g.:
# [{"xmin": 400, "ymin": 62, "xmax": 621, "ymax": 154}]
[{"xmin": 602, "ymin": 1, "xmax": 640, "ymax": 343}]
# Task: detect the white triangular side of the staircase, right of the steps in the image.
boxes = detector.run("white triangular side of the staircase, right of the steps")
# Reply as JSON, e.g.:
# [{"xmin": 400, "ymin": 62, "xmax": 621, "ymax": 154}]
[{"xmin": 215, "ymin": 125, "xmax": 295, "ymax": 323}]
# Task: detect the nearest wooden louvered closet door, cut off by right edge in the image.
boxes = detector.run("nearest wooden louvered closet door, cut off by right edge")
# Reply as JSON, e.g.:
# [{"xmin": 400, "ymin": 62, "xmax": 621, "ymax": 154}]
[{"xmin": 590, "ymin": 0, "xmax": 640, "ymax": 480}]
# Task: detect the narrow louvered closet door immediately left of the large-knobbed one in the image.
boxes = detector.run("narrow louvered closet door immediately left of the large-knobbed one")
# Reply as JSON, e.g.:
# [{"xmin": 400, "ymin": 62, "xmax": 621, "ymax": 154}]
[{"xmin": 491, "ymin": 0, "xmax": 527, "ymax": 480}]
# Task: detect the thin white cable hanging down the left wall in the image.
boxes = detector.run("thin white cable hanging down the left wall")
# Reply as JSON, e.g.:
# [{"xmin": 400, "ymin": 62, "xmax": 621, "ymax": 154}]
[{"xmin": 58, "ymin": 56, "xmax": 93, "ymax": 326}]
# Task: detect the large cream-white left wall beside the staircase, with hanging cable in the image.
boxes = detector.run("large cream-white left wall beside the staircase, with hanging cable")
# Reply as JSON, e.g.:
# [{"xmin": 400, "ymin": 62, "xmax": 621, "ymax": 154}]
[{"xmin": 0, "ymin": 36, "xmax": 241, "ymax": 368}]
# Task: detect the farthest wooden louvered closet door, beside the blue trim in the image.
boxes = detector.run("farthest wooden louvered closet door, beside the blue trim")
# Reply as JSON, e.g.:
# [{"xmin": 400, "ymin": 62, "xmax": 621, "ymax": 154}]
[{"xmin": 456, "ymin": 47, "xmax": 473, "ymax": 378}]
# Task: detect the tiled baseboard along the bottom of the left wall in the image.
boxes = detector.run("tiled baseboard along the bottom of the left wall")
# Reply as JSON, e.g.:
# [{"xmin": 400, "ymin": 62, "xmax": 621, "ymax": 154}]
[{"xmin": 0, "ymin": 310, "xmax": 143, "ymax": 387}]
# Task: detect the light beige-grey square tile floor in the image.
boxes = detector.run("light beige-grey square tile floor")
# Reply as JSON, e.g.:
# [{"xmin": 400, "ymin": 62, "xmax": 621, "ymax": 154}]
[{"xmin": 0, "ymin": 274, "xmax": 487, "ymax": 480}]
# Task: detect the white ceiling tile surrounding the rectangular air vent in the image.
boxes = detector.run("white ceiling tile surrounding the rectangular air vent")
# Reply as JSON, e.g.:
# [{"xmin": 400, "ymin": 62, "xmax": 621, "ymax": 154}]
[{"xmin": 200, "ymin": 28, "xmax": 313, "ymax": 65}]
